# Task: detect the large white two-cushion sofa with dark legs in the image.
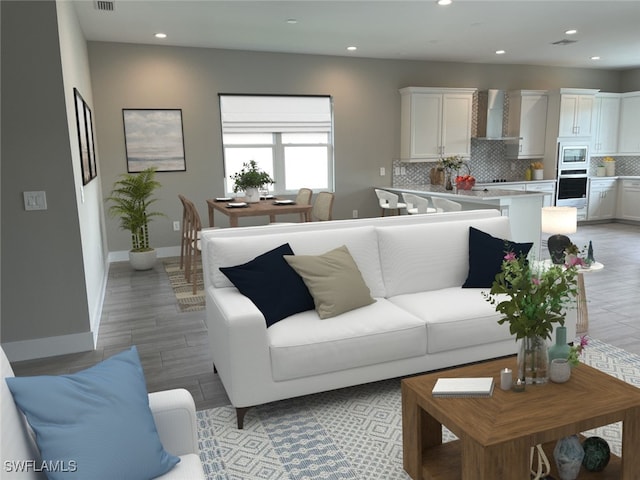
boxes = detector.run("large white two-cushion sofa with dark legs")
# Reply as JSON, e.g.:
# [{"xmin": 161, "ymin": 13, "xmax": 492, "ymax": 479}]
[{"xmin": 202, "ymin": 210, "xmax": 575, "ymax": 428}]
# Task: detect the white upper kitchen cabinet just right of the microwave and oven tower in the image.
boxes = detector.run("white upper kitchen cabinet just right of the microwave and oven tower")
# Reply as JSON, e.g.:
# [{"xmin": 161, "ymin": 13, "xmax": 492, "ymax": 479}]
[{"xmin": 591, "ymin": 93, "xmax": 620, "ymax": 156}]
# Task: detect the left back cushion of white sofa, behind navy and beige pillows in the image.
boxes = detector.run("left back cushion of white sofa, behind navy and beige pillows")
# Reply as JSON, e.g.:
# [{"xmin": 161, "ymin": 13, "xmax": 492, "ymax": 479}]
[{"xmin": 205, "ymin": 226, "xmax": 385, "ymax": 297}]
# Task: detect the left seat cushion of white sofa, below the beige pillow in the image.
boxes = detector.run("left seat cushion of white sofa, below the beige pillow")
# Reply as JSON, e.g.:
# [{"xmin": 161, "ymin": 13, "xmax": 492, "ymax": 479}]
[{"xmin": 267, "ymin": 298, "xmax": 427, "ymax": 381}]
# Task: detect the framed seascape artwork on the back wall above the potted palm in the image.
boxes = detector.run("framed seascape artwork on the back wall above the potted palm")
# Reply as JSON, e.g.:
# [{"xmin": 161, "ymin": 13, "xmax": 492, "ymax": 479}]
[{"xmin": 122, "ymin": 108, "xmax": 187, "ymax": 173}]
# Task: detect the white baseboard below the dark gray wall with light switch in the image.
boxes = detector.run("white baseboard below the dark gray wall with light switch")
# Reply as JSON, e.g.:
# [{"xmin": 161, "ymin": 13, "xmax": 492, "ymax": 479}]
[{"xmin": 2, "ymin": 332, "xmax": 95, "ymax": 362}]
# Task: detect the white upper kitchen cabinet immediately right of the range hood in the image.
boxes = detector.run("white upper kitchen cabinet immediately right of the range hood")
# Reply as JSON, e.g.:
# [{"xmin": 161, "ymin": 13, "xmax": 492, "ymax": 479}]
[{"xmin": 507, "ymin": 90, "xmax": 548, "ymax": 158}]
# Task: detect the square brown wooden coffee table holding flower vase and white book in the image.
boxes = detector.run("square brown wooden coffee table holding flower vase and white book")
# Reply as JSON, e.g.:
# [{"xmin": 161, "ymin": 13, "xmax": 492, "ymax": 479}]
[{"xmin": 402, "ymin": 357, "xmax": 640, "ymax": 480}]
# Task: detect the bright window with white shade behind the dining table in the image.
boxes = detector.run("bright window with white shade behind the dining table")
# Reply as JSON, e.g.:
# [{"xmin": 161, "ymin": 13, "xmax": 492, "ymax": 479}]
[{"xmin": 220, "ymin": 95, "xmax": 334, "ymax": 194}]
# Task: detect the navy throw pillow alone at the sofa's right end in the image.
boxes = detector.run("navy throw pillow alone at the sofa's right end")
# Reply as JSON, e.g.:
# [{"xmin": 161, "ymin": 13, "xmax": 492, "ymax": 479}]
[{"xmin": 462, "ymin": 227, "xmax": 533, "ymax": 288}]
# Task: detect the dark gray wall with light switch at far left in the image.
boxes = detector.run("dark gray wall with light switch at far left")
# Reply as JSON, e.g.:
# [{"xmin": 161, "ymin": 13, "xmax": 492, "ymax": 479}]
[{"xmin": 1, "ymin": 2, "xmax": 89, "ymax": 348}]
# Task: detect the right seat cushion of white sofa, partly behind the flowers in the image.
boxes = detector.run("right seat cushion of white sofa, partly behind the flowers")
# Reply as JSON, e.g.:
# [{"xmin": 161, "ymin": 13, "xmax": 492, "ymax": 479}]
[{"xmin": 389, "ymin": 287, "xmax": 515, "ymax": 353}]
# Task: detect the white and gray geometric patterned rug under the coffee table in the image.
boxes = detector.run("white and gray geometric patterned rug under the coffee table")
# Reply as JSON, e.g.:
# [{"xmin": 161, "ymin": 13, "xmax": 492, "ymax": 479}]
[{"xmin": 197, "ymin": 340, "xmax": 640, "ymax": 480}]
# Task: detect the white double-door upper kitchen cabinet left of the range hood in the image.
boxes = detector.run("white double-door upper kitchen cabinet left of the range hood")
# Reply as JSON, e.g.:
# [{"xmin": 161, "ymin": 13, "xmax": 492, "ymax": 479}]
[{"xmin": 400, "ymin": 87, "xmax": 476, "ymax": 161}]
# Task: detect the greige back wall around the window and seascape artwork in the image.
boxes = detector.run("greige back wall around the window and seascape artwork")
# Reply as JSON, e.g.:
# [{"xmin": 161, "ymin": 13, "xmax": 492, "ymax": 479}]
[{"xmin": 89, "ymin": 42, "xmax": 621, "ymax": 252}]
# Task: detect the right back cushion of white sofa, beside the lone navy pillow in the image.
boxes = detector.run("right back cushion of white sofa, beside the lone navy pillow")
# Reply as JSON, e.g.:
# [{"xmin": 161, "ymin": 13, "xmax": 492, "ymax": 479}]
[{"xmin": 377, "ymin": 217, "xmax": 511, "ymax": 298}]
